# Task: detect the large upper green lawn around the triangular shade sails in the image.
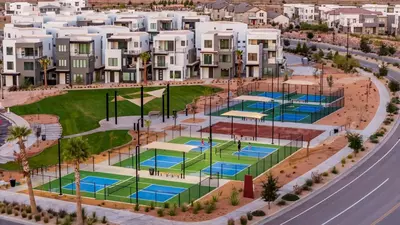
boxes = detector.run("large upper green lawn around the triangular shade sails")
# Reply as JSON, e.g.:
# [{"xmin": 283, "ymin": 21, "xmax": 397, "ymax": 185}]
[{"xmin": 11, "ymin": 86, "xmax": 219, "ymax": 136}]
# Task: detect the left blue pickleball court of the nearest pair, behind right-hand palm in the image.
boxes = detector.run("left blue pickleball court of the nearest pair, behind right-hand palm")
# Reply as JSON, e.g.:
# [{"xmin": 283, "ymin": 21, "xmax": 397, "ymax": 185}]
[{"xmin": 63, "ymin": 176, "xmax": 119, "ymax": 193}]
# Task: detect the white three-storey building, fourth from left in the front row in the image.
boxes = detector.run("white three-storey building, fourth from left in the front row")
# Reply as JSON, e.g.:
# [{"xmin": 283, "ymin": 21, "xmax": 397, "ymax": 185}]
[{"xmin": 152, "ymin": 30, "xmax": 199, "ymax": 81}]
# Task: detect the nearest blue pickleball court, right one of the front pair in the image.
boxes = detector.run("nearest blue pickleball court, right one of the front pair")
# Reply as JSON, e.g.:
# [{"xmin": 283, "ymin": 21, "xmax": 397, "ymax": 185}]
[{"xmin": 130, "ymin": 184, "xmax": 186, "ymax": 202}]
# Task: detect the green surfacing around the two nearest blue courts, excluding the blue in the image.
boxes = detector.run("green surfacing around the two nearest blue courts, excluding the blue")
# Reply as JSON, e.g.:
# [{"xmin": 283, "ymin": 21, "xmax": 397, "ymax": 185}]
[{"xmin": 35, "ymin": 171, "xmax": 214, "ymax": 207}]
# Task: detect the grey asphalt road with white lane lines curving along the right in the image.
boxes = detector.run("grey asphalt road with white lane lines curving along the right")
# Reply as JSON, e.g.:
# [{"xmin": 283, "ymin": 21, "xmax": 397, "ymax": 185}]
[{"xmin": 262, "ymin": 46, "xmax": 400, "ymax": 225}]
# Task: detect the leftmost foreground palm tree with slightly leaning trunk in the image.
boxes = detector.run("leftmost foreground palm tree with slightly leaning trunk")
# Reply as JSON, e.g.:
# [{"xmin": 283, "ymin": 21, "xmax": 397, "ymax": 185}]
[{"xmin": 7, "ymin": 126, "xmax": 37, "ymax": 214}]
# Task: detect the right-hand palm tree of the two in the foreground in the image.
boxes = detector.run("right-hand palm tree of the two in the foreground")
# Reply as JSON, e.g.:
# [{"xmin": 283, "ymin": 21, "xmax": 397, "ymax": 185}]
[{"xmin": 63, "ymin": 137, "xmax": 90, "ymax": 225}]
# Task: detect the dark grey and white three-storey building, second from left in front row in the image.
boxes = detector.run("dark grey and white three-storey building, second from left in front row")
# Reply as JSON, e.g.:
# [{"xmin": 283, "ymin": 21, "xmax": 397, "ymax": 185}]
[{"xmin": 55, "ymin": 34, "xmax": 104, "ymax": 85}]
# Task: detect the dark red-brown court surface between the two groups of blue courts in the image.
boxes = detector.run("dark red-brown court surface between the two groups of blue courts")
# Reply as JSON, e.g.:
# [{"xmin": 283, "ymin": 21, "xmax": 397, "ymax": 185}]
[{"xmin": 201, "ymin": 122, "xmax": 323, "ymax": 141}]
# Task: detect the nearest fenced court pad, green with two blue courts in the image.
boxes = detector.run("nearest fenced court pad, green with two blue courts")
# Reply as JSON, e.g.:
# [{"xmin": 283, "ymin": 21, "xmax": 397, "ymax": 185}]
[{"xmin": 35, "ymin": 171, "xmax": 214, "ymax": 207}]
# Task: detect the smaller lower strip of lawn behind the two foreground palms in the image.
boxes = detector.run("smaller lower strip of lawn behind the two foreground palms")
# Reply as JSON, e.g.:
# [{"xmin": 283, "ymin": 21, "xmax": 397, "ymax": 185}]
[{"xmin": 0, "ymin": 130, "xmax": 132, "ymax": 170}]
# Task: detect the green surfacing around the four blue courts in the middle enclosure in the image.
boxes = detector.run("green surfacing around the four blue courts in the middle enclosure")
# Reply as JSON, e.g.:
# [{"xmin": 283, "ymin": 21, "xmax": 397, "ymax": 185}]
[{"xmin": 114, "ymin": 137, "xmax": 298, "ymax": 180}]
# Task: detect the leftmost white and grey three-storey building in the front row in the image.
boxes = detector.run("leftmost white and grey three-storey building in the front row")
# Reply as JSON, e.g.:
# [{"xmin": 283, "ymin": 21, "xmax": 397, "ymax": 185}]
[{"xmin": 1, "ymin": 35, "xmax": 55, "ymax": 86}]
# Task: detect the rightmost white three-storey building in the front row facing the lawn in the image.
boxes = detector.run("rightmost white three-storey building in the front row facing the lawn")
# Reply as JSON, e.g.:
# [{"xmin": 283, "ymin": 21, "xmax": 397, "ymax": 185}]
[{"xmin": 245, "ymin": 29, "xmax": 285, "ymax": 78}]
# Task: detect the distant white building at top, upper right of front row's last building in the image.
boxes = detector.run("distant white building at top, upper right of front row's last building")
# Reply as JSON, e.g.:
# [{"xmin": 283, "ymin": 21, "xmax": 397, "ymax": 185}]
[{"xmin": 283, "ymin": 4, "xmax": 318, "ymax": 23}]
